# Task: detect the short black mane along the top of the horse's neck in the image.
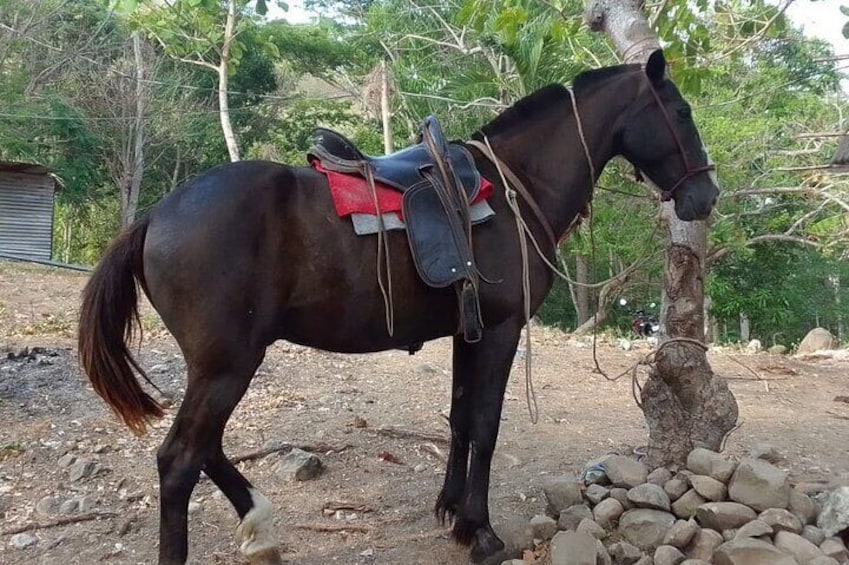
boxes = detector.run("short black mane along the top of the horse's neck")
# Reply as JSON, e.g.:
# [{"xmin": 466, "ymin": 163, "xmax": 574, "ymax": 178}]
[{"xmin": 475, "ymin": 65, "xmax": 635, "ymax": 137}]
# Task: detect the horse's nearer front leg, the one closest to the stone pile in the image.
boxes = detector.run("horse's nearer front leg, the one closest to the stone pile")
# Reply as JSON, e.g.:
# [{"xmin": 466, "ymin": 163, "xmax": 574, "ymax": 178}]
[{"xmin": 454, "ymin": 320, "xmax": 521, "ymax": 563}]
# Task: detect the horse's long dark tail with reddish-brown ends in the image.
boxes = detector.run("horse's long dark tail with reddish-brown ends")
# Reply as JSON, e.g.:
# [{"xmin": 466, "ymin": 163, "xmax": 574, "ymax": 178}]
[{"xmin": 78, "ymin": 216, "xmax": 163, "ymax": 434}]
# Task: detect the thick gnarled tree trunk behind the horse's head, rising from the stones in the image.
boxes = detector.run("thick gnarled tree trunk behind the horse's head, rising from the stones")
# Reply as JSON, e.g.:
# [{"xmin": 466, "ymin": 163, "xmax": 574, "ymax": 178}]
[{"xmin": 586, "ymin": 0, "xmax": 737, "ymax": 465}]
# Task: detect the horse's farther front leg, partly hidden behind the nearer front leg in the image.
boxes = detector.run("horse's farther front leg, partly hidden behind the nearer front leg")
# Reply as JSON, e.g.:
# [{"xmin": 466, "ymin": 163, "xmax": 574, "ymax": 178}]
[{"xmin": 435, "ymin": 336, "xmax": 471, "ymax": 524}]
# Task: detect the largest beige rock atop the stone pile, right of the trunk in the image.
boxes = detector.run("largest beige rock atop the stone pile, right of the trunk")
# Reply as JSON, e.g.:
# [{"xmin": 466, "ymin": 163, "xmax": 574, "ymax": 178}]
[{"xmin": 728, "ymin": 459, "xmax": 790, "ymax": 512}]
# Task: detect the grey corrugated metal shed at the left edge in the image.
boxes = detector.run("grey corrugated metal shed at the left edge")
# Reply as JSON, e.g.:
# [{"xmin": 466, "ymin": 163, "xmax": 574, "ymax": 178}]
[{"xmin": 0, "ymin": 161, "xmax": 56, "ymax": 260}]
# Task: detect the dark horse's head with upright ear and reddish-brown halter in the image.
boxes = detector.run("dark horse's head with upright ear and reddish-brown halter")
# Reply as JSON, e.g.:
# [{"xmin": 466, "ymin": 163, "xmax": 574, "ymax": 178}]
[{"xmin": 622, "ymin": 50, "xmax": 719, "ymax": 221}]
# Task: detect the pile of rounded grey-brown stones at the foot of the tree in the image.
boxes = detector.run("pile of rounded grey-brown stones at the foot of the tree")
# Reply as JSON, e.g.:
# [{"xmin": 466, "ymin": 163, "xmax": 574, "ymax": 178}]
[{"xmin": 520, "ymin": 449, "xmax": 849, "ymax": 565}]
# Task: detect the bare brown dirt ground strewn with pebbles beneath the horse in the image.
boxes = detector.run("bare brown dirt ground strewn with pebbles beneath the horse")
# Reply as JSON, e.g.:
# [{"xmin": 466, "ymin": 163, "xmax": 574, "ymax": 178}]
[{"xmin": 0, "ymin": 262, "xmax": 849, "ymax": 565}]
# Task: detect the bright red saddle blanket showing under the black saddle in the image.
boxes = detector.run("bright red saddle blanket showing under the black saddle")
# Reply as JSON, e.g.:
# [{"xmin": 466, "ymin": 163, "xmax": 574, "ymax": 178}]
[{"xmin": 312, "ymin": 160, "xmax": 494, "ymax": 219}]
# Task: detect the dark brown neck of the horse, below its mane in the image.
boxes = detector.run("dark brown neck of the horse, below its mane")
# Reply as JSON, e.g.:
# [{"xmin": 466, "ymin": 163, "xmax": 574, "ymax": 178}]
[{"xmin": 494, "ymin": 75, "xmax": 630, "ymax": 237}]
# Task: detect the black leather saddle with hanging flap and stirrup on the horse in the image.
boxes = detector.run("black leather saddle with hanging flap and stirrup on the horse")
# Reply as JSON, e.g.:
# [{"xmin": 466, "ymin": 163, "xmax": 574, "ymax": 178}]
[{"xmin": 307, "ymin": 116, "xmax": 483, "ymax": 341}]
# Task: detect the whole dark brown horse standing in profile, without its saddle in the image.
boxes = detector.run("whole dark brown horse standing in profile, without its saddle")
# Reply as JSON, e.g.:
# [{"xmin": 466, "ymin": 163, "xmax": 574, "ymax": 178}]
[{"xmin": 79, "ymin": 51, "xmax": 717, "ymax": 564}]
